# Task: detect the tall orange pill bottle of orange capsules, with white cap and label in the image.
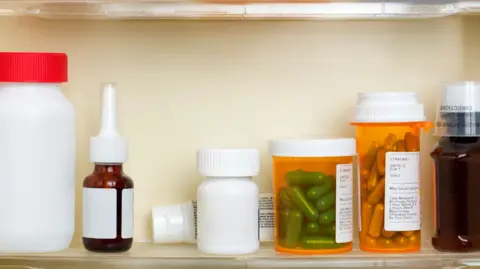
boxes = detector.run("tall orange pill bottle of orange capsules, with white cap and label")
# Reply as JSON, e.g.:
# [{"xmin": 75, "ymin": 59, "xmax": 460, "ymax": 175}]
[{"xmin": 352, "ymin": 92, "xmax": 428, "ymax": 253}]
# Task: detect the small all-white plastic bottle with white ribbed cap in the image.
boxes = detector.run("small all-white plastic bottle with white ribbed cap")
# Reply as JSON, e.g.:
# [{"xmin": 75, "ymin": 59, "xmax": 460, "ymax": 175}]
[{"xmin": 197, "ymin": 149, "xmax": 260, "ymax": 255}]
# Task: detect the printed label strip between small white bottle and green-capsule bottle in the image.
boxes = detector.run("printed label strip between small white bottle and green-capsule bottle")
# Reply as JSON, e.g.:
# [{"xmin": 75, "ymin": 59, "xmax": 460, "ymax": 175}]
[{"xmin": 258, "ymin": 193, "xmax": 274, "ymax": 242}]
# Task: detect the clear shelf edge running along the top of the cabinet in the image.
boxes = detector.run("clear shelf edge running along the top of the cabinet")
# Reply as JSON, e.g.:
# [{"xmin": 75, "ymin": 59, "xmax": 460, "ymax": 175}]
[{"xmin": 0, "ymin": 0, "xmax": 480, "ymax": 19}]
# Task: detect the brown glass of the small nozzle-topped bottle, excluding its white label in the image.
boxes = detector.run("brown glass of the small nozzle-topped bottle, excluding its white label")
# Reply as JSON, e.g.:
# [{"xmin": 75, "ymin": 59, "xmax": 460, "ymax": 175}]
[{"xmin": 82, "ymin": 165, "xmax": 133, "ymax": 252}]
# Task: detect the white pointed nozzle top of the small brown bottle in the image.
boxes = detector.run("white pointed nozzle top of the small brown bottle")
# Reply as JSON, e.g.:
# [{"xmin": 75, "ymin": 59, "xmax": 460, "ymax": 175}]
[{"xmin": 90, "ymin": 84, "xmax": 128, "ymax": 164}]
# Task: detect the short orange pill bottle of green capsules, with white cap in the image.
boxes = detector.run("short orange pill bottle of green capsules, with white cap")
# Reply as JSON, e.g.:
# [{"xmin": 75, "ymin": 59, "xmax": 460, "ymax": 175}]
[{"xmin": 270, "ymin": 138, "xmax": 356, "ymax": 254}]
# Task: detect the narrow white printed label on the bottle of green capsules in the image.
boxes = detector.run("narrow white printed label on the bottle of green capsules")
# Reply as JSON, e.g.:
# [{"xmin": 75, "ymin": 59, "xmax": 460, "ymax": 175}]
[{"xmin": 335, "ymin": 164, "xmax": 353, "ymax": 243}]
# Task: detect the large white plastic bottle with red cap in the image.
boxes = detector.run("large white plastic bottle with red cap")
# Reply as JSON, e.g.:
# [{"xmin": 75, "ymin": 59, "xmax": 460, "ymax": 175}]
[{"xmin": 0, "ymin": 53, "xmax": 75, "ymax": 253}]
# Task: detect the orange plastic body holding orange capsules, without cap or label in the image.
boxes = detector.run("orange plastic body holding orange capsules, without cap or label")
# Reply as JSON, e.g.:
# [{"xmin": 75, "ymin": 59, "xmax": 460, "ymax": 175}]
[{"xmin": 354, "ymin": 122, "xmax": 425, "ymax": 253}]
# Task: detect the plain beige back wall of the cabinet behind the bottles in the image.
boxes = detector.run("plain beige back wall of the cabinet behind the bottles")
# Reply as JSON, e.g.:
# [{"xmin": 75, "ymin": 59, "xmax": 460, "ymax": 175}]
[{"xmin": 0, "ymin": 17, "xmax": 468, "ymax": 242}]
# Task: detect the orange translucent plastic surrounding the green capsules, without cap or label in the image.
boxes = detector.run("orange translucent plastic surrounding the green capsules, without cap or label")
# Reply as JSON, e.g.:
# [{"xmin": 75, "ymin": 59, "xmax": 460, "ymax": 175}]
[{"xmin": 273, "ymin": 156, "xmax": 353, "ymax": 254}]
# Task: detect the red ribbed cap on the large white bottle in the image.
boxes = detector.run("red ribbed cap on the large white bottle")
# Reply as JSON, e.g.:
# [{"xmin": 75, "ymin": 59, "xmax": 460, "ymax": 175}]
[{"xmin": 0, "ymin": 52, "xmax": 68, "ymax": 83}]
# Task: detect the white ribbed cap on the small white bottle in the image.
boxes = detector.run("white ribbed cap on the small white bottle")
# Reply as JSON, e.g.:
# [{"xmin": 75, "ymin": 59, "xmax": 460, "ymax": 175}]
[{"xmin": 197, "ymin": 149, "xmax": 260, "ymax": 177}]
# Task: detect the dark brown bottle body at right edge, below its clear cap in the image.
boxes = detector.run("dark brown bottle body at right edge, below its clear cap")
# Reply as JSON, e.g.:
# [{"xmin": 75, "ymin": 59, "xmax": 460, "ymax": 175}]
[{"xmin": 431, "ymin": 137, "xmax": 480, "ymax": 252}]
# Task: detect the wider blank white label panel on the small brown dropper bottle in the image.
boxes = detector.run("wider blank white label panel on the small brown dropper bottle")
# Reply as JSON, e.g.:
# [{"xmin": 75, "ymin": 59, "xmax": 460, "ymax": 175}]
[{"xmin": 83, "ymin": 188, "xmax": 117, "ymax": 239}]
